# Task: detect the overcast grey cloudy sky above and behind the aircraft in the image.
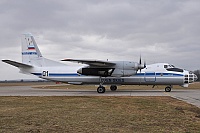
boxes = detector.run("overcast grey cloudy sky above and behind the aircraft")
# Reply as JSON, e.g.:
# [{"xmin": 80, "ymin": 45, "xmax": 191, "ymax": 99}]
[{"xmin": 0, "ymin": 0, "xmax": 200, "ymax": 80}]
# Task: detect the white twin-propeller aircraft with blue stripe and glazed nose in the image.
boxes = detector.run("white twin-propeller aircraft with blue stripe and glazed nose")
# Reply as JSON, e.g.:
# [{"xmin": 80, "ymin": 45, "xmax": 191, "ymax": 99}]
[{"xmin": 2, "ymin": 33, "xmax": 197, "ymax": 93}]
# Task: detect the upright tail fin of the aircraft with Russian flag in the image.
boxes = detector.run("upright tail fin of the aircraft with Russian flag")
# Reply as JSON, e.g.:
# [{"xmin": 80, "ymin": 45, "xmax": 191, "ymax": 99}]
[{"xmin": 21, "ymin": 33, "xmax": 42, "ymax": 66}]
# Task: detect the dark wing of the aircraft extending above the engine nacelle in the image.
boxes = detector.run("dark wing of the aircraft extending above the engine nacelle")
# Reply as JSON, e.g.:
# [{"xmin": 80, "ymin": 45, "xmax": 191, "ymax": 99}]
[{"xmin": 61, "ymin": 59, "xmax": 116, "ymax": 67}]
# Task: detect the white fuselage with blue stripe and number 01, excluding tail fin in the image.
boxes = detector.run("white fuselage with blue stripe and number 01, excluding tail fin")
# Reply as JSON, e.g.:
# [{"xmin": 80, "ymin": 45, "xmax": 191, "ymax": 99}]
[{"xmin": 23, "ymin": 63, "xmax": 197, "ymax": 87}]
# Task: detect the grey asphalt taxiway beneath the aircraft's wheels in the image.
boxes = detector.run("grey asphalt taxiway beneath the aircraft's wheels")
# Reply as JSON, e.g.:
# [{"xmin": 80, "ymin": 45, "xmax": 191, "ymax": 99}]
[{"xmin": 0, "ymin": 86, "xmax": 200, "ymax": 108}]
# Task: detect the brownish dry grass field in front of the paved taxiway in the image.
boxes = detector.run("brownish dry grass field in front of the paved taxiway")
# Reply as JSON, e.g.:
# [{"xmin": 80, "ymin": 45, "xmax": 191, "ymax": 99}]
[{"xmin": 0, "ymin": 97, "xmax": 200, "ymax": 133}]
